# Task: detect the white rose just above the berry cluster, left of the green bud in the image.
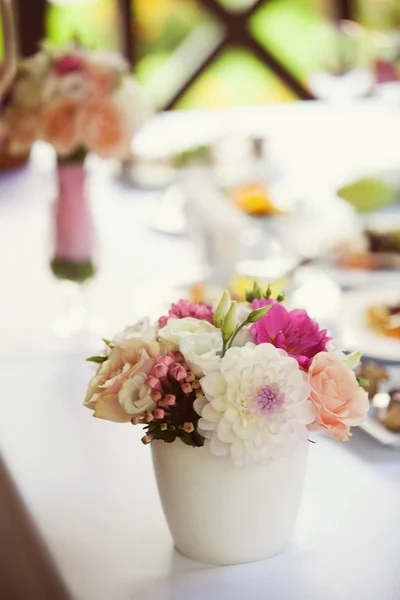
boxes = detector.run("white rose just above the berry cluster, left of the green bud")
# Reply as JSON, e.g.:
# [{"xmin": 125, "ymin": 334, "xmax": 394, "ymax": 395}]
[{"xmin": 180, "ymin": 331, "xmax": 222, "ymax": 377}]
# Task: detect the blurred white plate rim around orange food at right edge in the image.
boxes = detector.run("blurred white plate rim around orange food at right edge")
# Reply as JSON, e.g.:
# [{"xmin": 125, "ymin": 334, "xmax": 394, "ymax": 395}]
[{"xmin": 340, "ymin": 286, "xmax": 400, "ymax": 362}]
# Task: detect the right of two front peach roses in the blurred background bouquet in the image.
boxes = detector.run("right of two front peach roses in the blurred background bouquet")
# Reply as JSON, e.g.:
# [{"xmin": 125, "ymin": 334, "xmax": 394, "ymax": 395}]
[{"xmin": 82, "ymin": 98, "xmax": 131, "ymax": 158}]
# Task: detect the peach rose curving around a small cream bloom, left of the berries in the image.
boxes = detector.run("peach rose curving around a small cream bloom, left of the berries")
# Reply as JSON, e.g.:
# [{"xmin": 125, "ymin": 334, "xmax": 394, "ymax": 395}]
[{"xmin": 83, "ymin": 339, "xmax": 160, "ymax": 423}]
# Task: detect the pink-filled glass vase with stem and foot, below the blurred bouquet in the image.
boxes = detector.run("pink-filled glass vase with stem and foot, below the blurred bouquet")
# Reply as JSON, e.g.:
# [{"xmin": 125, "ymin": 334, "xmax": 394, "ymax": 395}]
[{"xmin": 51, "ymin": 161, "xmax": 95, "ymax": 337}]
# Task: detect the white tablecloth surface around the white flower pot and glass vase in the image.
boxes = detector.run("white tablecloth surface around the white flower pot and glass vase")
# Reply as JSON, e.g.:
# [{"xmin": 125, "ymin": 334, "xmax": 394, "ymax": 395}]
[{"xmin": 0, "ymin": 105, "xmax": 400, "ymax": 600}]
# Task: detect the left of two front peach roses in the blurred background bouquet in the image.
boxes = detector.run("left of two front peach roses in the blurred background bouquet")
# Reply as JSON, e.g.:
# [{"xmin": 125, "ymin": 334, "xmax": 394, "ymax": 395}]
[{"xmin": 42, "ymin": 98, "xmax": 81, "ymax": 156}]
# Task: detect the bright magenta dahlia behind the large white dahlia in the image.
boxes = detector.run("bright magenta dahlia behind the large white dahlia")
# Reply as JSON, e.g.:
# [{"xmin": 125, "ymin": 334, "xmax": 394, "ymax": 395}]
[{"xmin": 251, "ymin": 298, "xmax": 331, "ymax": 370}]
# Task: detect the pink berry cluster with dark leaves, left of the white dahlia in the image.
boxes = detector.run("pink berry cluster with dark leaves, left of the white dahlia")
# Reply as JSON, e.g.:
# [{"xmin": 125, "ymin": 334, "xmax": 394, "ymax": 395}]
[{"xmin": 137, "ymin": 352, "xmax": 204, "ymax": 446}]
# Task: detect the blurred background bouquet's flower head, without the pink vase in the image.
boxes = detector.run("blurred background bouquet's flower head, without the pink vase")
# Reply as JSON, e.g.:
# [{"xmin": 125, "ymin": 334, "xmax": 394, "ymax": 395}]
[{"xmin": 2, "ymin": 42, "xmax": 151, "ymax": 160}]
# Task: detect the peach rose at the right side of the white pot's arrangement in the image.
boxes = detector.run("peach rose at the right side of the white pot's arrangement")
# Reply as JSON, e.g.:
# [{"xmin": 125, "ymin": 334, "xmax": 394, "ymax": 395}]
[{"xmin": 308, "ymin": 352, "xmax": 369, "ymax": 440}]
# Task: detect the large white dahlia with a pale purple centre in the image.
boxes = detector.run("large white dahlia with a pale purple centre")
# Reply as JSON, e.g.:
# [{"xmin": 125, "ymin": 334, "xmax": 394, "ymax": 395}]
[{"xmin": 195, "ymin": 344, "xmax": 314, "ymax": 466}]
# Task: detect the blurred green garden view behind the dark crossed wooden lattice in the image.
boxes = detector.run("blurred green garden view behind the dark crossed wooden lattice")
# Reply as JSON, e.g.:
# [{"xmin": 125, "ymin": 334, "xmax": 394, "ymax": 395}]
[{"xmin": 12, "ymin": 0, "xmax": 400, "ymax": 108}]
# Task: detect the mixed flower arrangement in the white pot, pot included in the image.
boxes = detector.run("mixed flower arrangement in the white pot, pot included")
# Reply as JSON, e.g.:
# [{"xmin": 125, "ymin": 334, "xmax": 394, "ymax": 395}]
[{"xmin": 84, "ymin": 285, "xmax": 368, "ymax": 564}]
